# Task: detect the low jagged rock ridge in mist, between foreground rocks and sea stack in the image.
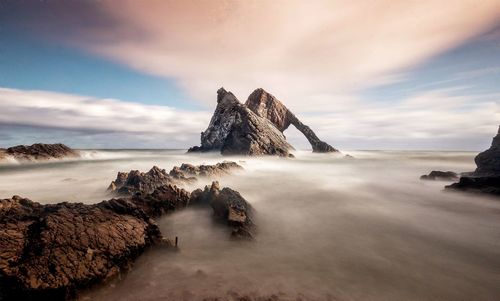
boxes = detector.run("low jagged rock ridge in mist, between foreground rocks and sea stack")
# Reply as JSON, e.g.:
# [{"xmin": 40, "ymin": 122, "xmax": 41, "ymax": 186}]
[{"xmin": 108, "ymin": 161, "xmax": 243, "ymax": 195}]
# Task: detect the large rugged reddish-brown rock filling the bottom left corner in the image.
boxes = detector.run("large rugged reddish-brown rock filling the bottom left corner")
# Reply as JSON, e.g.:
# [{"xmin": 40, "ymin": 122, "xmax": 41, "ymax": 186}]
[{"xmin": 0, "ymin": 197, "xmax": 162, "ymax": 300}]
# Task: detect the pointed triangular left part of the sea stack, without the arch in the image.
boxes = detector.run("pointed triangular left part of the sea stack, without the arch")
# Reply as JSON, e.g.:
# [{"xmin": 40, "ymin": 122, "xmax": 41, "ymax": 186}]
[{"xmin": 188, "ymin": 88, "xmax": 293, "ymax": 157}]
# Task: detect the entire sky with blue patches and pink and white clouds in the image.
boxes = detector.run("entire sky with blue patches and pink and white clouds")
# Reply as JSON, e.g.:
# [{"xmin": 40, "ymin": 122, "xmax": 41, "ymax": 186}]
[{"xmin": 0, "ymin": 0, "xmax": 500, "ymax": 151}]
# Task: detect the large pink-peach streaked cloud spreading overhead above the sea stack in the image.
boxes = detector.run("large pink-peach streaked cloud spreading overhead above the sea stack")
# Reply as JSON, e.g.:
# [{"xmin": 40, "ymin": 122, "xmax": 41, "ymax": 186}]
[{"xmin": 51, "ymin": 0, "xmax": 500, "ymax": 110}]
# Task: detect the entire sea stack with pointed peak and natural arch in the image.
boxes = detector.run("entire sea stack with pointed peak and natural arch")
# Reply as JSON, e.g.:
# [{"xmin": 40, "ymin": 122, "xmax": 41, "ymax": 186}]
[{"xmin": 188, "ymin": 88, "xmax": 337, "ymax": 157}]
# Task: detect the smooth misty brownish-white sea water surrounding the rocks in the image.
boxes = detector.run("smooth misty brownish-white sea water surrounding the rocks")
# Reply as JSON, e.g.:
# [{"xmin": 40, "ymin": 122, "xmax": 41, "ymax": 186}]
[{"xmin": 0, "ymin": 151, "xmax": 500, "ymax": 300}]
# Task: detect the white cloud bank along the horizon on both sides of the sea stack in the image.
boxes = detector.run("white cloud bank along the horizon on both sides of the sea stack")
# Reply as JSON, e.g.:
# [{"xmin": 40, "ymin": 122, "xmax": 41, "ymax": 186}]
[{"xmin": 0, "ymin": 88, "xmax": 500, "ymax": 150}]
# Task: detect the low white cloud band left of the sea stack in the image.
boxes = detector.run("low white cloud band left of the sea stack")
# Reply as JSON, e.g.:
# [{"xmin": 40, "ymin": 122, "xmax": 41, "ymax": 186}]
[{"xmin": 0, "ymin": 88, "xmax": 210, "ymax": 147}]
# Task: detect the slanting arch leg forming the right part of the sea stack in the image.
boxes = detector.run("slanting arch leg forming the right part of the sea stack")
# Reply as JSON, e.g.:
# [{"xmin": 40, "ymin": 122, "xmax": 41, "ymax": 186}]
[{"xmin": 245, "ymin": 88, "xmax": 338, "ymax": 153}]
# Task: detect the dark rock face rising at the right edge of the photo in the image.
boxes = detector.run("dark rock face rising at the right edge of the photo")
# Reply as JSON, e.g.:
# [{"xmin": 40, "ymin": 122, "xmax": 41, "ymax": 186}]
[{"xmin": 446, "ymin": 128, "xmax": 500, "ymax": 195}]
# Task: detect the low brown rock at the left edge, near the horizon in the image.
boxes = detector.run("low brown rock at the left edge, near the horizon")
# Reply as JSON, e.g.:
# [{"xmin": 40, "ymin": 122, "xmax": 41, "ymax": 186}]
[{"xmin": 0, "ymin": 143, "xmax": 80, "ymax": 161}]
